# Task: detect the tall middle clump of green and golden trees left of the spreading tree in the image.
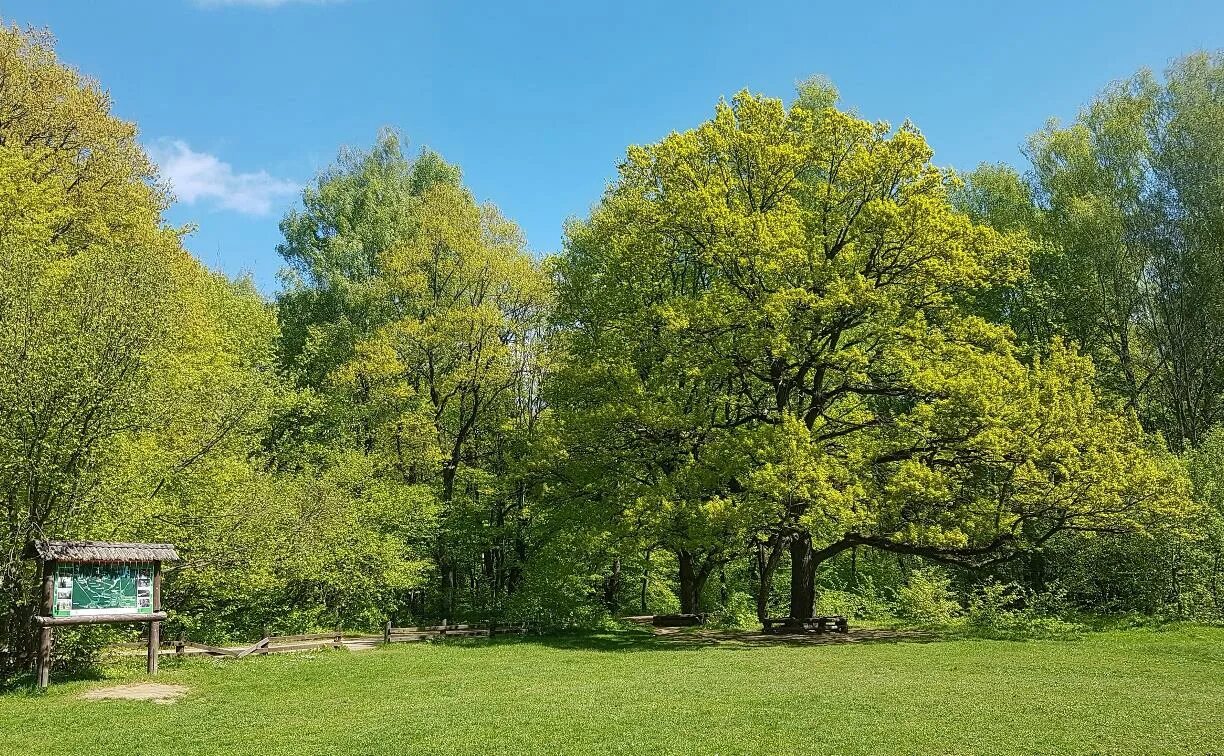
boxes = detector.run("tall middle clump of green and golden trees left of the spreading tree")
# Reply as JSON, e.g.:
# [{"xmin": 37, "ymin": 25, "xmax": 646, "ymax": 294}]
[{"xmin": 278, "ymin": 132, "xmax": 548, "ymax": 618}]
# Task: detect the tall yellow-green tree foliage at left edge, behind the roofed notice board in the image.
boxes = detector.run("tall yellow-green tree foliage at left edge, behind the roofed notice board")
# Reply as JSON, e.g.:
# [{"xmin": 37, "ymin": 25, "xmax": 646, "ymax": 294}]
[{"xmin": 0, "ymin": 23, "xmax": 244, "ymax": 674}]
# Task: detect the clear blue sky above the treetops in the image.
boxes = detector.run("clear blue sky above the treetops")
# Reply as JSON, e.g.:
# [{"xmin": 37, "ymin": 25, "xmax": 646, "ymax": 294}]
[{"xmin": 0, "ymin": 0, "xmax": 1224, "ymax": 294}]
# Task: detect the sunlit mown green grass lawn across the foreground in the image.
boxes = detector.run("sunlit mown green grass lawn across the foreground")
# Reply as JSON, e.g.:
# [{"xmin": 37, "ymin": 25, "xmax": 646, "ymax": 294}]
[{"xmin": 0, "ymin": 626, "xmax": 1224, "ymax": 756}]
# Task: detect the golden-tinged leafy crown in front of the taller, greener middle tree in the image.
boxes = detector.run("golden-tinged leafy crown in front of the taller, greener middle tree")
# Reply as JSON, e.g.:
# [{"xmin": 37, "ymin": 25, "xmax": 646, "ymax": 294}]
[{"xmin": 345, "ymin": 176, "xmax": 548, "ymax": 481}]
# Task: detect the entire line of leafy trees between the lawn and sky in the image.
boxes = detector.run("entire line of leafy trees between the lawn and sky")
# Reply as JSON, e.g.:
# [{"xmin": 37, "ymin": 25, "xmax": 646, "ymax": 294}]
[{"xmin": 0, "ymin": 27, "xmax": 1224, "ymax": 669}]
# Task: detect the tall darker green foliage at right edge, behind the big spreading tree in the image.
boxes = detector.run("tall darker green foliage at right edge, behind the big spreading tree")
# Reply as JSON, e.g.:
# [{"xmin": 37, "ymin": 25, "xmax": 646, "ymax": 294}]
[{"xmin": 958, "ymin": 53, "xmax": 1224, "ymax": 449}]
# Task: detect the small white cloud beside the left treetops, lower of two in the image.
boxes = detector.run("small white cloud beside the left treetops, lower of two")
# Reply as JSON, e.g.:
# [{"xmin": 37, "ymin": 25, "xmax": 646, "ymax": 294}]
[{"xmin": 149, "ymin": 139, "xmax": 299, "ymax": 215}]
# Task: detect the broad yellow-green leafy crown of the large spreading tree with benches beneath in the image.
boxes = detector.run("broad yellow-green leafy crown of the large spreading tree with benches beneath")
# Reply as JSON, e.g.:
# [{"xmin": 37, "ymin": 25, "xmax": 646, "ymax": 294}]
[{"xmin": 558, "ymin": 82, "xmax": 1185, "ymax": 577}]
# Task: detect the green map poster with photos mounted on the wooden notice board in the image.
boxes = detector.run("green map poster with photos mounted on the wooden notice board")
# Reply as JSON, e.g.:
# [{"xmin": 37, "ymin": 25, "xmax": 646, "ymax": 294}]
[{"xmin": 53, "ymin": 563, "xmax": 153, "ymax": 617}]
